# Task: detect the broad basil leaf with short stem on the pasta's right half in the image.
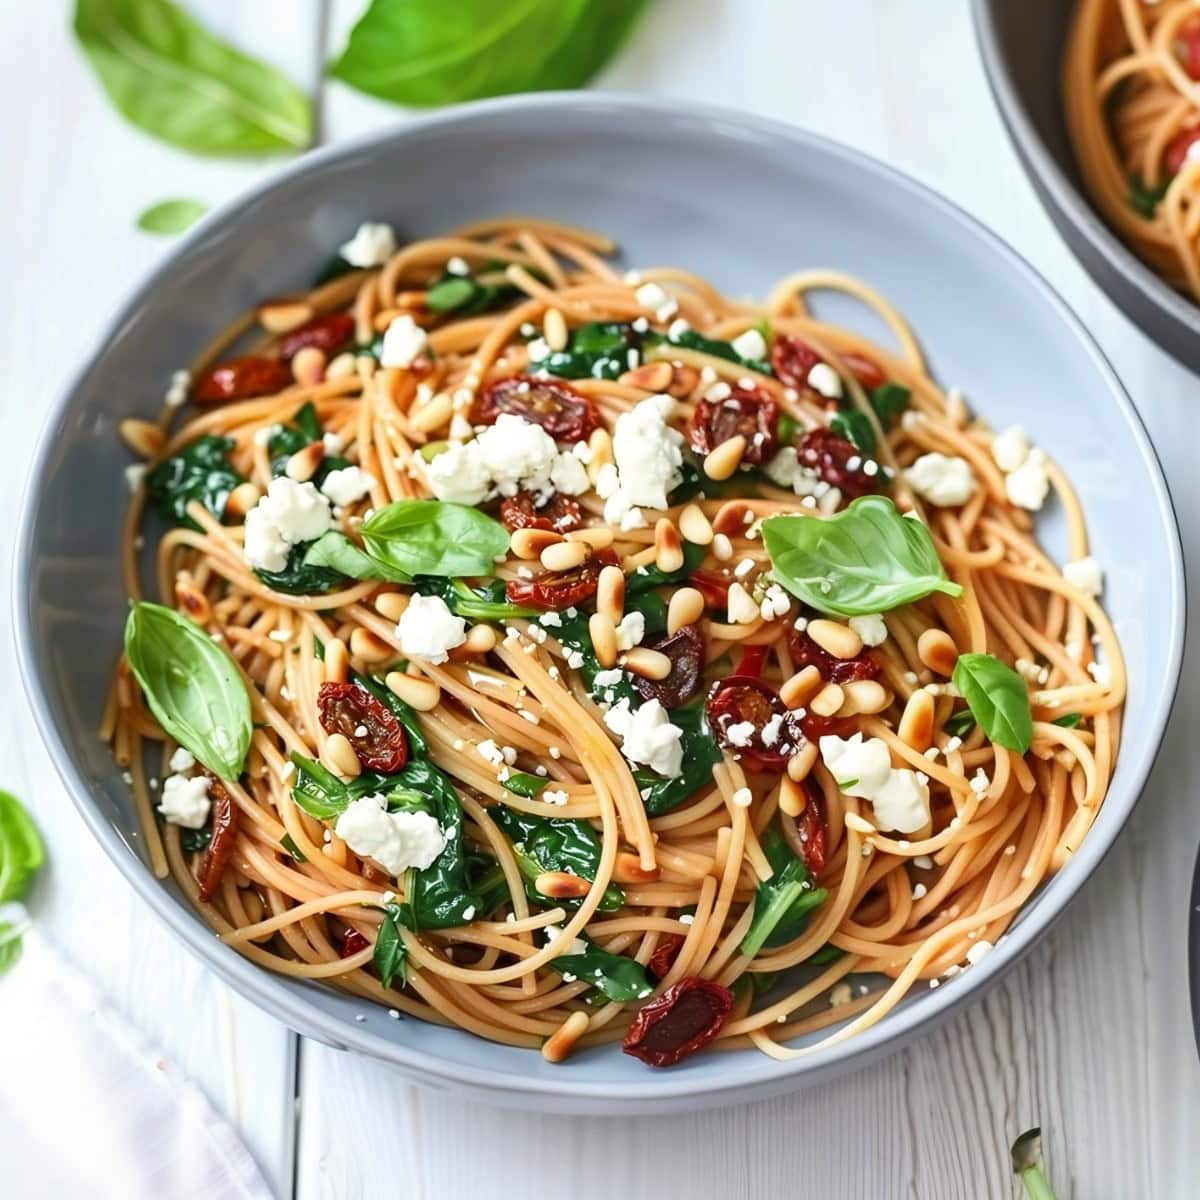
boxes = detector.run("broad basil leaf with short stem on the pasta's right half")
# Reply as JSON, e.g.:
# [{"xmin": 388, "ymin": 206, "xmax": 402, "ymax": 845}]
[{"xmin": 762, "ymin": 496, "xmax": 962, "ymax": 617}]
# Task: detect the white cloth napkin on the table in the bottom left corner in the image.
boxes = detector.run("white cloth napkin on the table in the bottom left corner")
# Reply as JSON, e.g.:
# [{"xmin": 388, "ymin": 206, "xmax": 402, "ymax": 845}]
[{"xmin": 0, "ymin": 930, "xmax": 271, "ymax": 1200}]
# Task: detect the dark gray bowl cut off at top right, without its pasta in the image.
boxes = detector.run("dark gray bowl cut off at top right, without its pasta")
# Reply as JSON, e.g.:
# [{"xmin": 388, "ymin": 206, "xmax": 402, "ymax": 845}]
[{"xmin": 972, "ymin": 0, "xmax": 1200, "ymax": 371}]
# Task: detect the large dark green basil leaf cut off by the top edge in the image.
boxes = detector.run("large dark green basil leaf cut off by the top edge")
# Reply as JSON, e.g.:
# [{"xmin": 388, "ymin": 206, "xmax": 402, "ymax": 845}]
[{"xmin": 330, "ymin": 0, "xmax": 644, "ymax": 108}]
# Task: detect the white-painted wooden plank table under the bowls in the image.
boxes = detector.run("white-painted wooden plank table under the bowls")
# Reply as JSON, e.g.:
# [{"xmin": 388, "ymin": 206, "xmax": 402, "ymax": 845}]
[{"xmin": 0, "ymin": 0, "xmax": 1200, "ymax": 1200}]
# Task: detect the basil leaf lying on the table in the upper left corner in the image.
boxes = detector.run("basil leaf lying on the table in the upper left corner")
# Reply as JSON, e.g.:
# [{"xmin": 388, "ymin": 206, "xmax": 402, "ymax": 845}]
[{"xmin": 74, "ymin": 0, "xmax": 312, "ymax": 155}]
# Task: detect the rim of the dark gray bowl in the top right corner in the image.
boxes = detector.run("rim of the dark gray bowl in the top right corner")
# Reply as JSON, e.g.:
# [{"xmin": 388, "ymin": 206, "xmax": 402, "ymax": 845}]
[{"xmin": 971, "ymin": 0, "xmax": 1200, "ymax": 345}]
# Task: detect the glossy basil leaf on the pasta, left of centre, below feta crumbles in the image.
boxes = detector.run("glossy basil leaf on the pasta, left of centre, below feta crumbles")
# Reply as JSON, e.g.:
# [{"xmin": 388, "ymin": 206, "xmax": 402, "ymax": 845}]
[{"xmin": 361, "ymin": 500, "xmax": 509, "ymax": 578}]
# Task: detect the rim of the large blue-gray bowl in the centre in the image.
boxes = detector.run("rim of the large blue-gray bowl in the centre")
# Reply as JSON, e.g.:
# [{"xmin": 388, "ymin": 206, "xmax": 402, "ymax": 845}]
[{"xmin": 13, "ymin": 91, "xmax": 1186, "ymax": 1115}]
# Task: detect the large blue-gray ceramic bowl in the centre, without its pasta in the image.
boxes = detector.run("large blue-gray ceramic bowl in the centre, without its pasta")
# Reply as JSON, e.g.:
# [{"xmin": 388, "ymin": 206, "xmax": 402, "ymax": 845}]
[{"xmin": 14, "ymin": 94, "xmax": 1183, "ymax": 1114}]
